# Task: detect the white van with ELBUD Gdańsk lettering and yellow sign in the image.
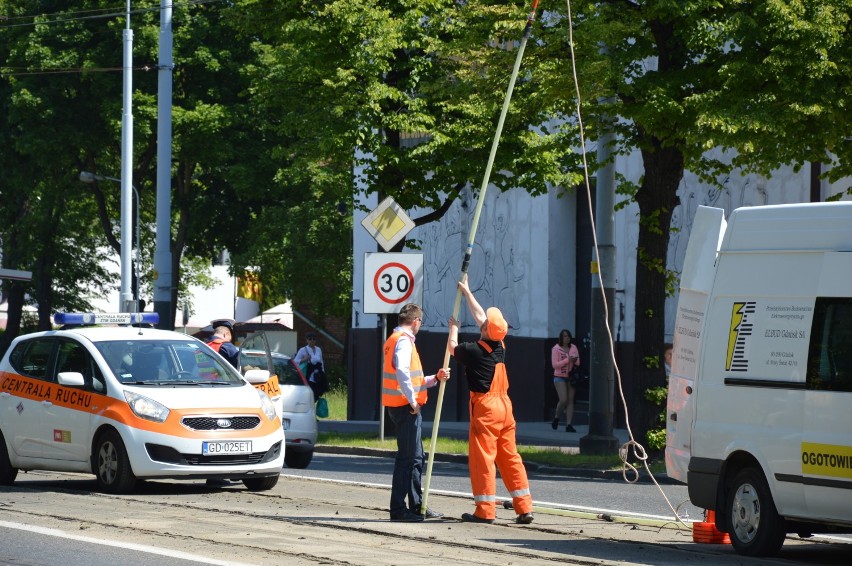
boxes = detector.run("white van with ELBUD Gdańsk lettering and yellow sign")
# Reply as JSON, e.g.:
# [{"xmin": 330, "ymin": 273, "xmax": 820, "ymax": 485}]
[{"xmin": 666, "ymin": 202, "xmax": 852, "ymax": 556}]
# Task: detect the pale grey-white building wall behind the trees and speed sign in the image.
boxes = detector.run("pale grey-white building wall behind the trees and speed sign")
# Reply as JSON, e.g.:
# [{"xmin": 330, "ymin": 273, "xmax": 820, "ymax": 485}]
[{"xmin": 352, "ymin": 153, "xmax": 849, "ymax": 342}]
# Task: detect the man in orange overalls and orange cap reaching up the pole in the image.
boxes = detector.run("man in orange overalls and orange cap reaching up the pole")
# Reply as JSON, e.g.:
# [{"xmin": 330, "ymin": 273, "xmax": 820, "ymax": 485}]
[{"xmin": 447, "ymin": 275, "xmax": 533, "ymax": 525}]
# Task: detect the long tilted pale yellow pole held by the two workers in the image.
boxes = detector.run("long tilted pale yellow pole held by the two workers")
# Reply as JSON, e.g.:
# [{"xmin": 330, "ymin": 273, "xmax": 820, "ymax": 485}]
[{"xmin": 420, "ymin": 0, "xmax": 538, "ymax": 514}]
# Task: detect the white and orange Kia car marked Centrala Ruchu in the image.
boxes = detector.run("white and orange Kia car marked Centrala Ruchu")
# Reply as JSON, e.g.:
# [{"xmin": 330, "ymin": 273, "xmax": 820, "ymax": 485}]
[{"xmin": 0, "ymin": 313, "xmax": 285, "ymax": 493}]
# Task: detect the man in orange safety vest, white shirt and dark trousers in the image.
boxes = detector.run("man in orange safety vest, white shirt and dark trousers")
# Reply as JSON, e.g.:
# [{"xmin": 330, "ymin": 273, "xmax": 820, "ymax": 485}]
[{"xmin": 382, "ymin": 303, "xmax": 450, "ymax": 523}]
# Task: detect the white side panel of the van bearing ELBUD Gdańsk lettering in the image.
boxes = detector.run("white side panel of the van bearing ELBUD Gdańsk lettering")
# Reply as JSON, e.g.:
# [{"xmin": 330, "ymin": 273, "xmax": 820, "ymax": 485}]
[{"xmin": 690, "ymin": 251, "xmax": 822, "ymax": 516}]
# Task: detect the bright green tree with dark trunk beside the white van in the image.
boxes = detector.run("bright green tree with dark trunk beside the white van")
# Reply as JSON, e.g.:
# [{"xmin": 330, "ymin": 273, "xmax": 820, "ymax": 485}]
[{"xmin": 240, "ymin": 0, "xmax": 852, "ymax": 440}]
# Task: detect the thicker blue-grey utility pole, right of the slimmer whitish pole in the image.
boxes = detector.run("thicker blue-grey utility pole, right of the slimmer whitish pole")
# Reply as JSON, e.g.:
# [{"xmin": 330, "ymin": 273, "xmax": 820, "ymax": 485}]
[{"xmin": 154, "ymin": 0, "xmax": 175, "ymax": 330}]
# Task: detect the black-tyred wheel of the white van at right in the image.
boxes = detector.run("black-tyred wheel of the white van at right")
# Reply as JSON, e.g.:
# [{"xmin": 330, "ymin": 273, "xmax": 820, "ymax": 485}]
[{"xmin": 726, "ymin": 467, "xmax": 787, "ymax": 556}]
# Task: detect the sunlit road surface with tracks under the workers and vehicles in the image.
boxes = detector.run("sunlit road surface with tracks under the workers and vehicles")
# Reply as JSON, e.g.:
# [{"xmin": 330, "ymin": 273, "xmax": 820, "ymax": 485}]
[{"xmin": 0, "ymin": 462, "xmax": 852, "ymax": 566}]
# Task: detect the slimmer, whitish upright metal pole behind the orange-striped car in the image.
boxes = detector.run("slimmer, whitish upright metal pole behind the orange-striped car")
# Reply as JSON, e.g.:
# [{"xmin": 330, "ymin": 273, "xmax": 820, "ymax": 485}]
[{"xmin": 119, "ymin": 0, "xmax": 133, "ymax": 312}]
